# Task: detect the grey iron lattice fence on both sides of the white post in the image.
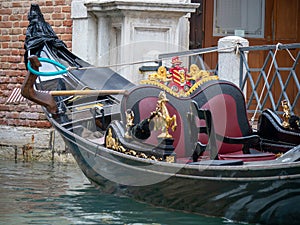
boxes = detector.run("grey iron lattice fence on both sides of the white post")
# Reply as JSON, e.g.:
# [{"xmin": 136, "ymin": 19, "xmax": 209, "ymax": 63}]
[{"xmin": 159, "ymin": 43, "xmax": 300, "ymax": 115}]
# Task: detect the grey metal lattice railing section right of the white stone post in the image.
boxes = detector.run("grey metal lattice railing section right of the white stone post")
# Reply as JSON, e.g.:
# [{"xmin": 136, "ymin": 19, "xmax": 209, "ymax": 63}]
[{"xmin": 239, "ymin": 43, "xmax": 300, "ymax": 114}]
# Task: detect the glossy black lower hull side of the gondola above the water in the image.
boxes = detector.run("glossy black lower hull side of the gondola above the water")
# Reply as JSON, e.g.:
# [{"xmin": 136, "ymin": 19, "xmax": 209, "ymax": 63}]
[{"xmin": 50, "ymin": 119, "xmax": 300, "ymax": 224}]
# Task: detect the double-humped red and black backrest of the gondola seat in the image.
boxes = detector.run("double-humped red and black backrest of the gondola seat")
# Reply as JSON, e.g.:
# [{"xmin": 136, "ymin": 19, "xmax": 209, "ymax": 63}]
[{"xmin": 121, "ymin": 80, "xmax": 251, "ymax": 157}]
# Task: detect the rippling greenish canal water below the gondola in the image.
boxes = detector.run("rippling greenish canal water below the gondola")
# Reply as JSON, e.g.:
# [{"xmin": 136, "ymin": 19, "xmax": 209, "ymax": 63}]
[{"xmin": 0, "ymin": 160, "xmax": 244, "ymax": 225}]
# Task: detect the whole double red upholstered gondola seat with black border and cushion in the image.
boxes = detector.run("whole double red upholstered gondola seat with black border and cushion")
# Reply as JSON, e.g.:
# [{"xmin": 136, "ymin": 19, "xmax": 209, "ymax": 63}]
[{"xmin": 121, "ymin": 80, "xmax": 275, "ymax": 161}]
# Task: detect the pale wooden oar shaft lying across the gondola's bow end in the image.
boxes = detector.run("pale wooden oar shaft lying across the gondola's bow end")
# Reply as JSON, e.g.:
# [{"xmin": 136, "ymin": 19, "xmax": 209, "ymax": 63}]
[{"xmin": 50, "ymin": 90, "xmax": 127, "ymax": 96}]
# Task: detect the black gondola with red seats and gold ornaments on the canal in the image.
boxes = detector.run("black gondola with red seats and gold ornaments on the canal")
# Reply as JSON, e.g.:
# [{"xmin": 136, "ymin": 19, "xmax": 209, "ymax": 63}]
[{"xmin": 22, "ymin": 5, "xmax": 300, "ymax": 224}]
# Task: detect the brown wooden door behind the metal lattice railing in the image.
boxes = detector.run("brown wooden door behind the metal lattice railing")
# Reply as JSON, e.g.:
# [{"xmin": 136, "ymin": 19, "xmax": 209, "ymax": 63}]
[{"xmin": 202, "ymin": 0, "xmax": 300, "ymax": 115}]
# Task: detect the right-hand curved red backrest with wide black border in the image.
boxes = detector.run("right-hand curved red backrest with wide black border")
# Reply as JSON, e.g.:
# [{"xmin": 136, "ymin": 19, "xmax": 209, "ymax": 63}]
[{"xmin": 193, "ymin": 81, "xmax": 252, "ymax": 154}]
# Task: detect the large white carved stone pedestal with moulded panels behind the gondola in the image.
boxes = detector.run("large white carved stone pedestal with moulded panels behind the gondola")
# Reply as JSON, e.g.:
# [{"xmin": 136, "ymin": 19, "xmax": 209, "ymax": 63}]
[{"xmin": 78, "ymin": 0, "xmax": 199, "ymax": 83}]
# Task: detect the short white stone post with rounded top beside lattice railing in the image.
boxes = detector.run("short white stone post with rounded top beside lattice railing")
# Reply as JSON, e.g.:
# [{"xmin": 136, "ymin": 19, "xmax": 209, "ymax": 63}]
[{"xmin": 218, "ymin": 36, "xmax": 249, "ymax": 86}]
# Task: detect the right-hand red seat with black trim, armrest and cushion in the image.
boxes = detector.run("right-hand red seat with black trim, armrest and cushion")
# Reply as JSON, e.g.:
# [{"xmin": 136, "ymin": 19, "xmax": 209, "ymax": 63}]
[{"xmin": 193, "ymin": 82, "xmax": 276, "ymax": 161}]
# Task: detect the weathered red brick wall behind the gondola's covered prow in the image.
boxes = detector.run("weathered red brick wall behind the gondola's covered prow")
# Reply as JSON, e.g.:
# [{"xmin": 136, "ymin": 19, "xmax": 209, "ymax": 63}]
[{"xmin": 0, "ymin": 0, "xmax": 72, "ymax": 128}]
